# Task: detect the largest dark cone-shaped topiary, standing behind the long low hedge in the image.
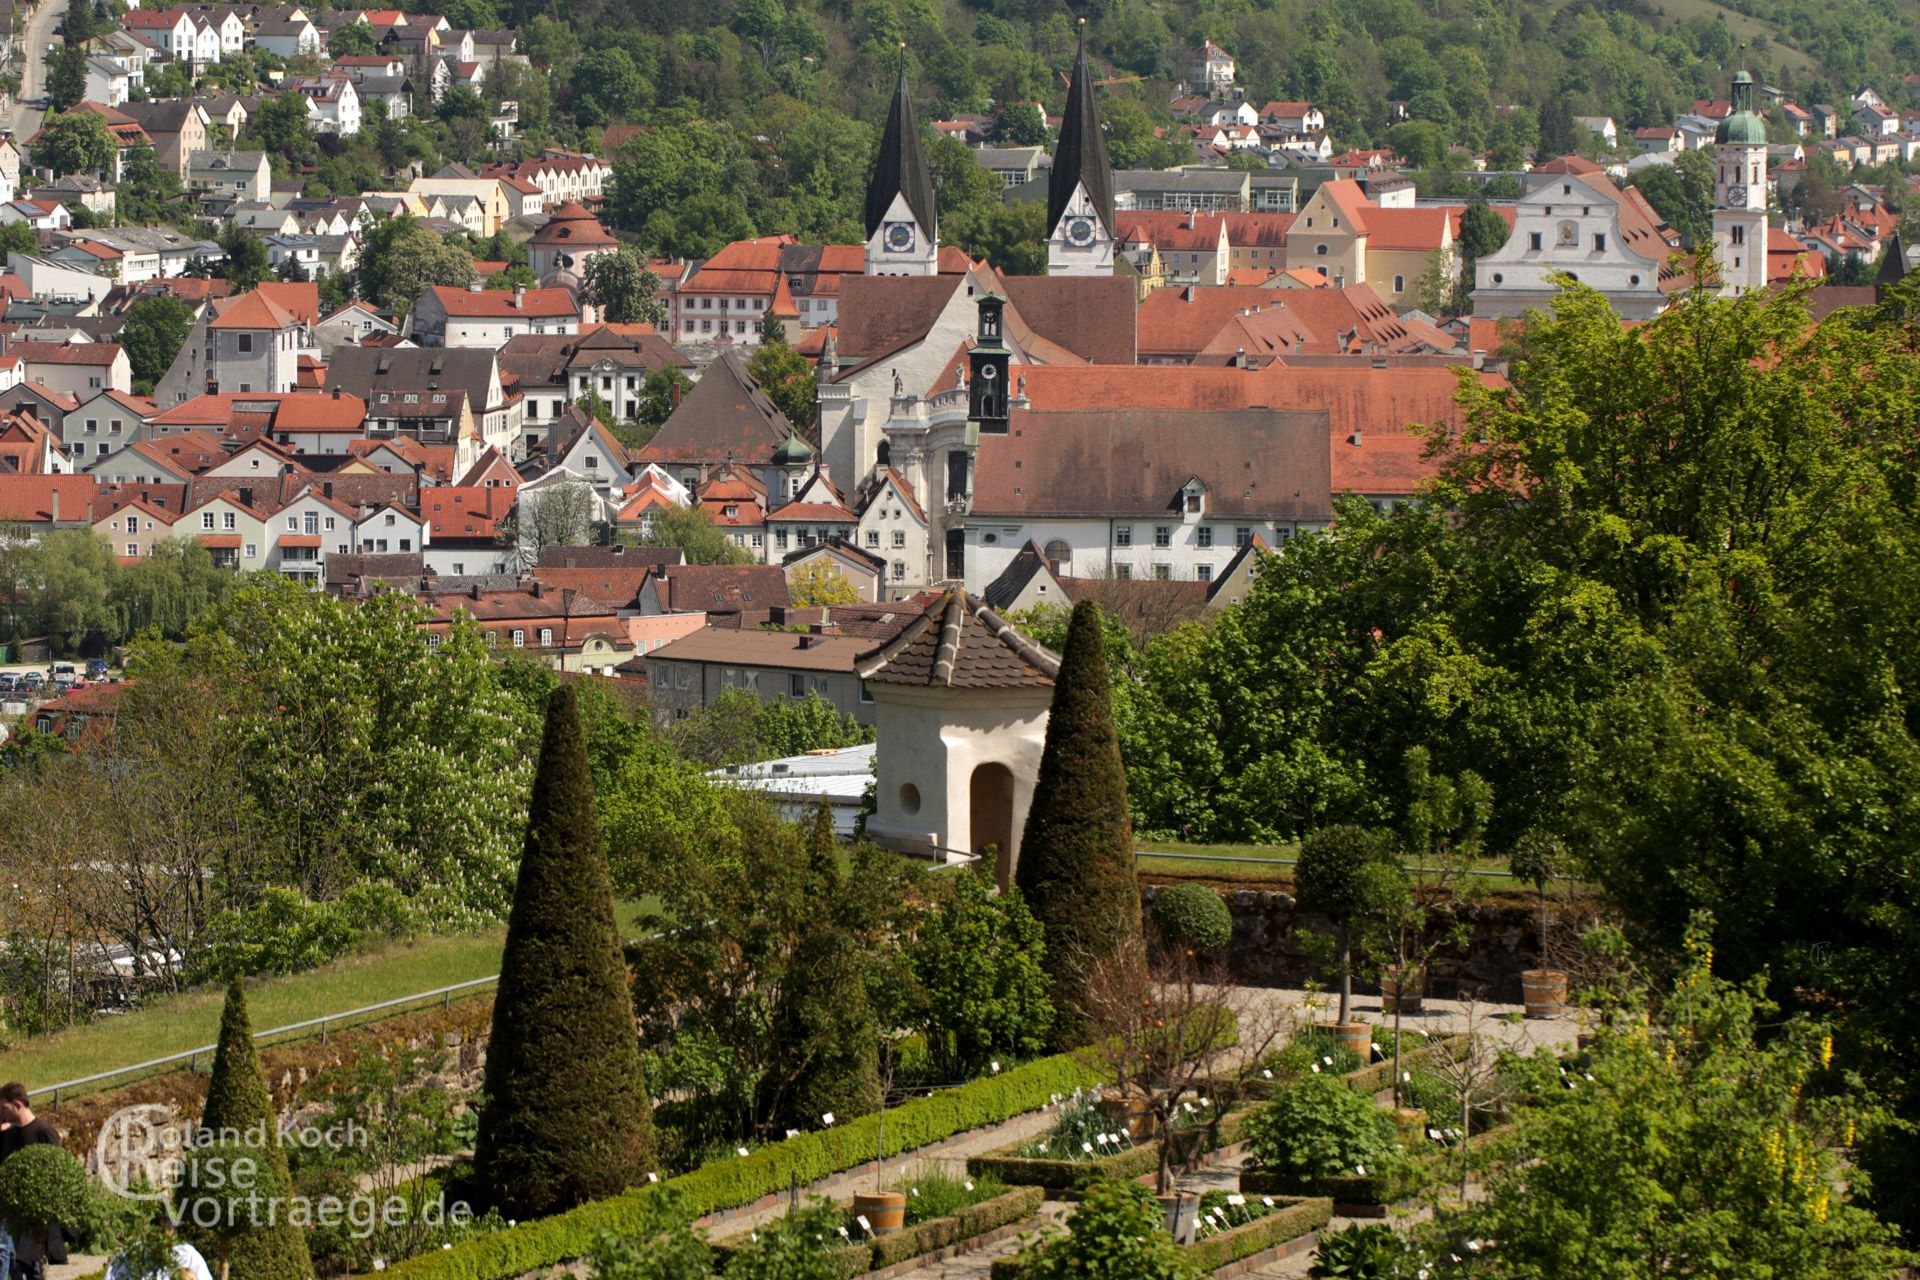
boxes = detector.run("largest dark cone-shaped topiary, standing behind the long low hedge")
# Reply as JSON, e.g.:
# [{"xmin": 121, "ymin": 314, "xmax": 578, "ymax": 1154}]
[{"xmin": 472, "ymin": 685, "xmax": 653, "ymax": 1219}]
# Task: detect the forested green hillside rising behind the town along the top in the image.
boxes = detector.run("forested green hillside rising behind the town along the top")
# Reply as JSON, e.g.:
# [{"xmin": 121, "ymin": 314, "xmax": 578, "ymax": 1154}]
[{"xmin": 453, "ymin": 0, "xmax": 1920, "ymax": 253}]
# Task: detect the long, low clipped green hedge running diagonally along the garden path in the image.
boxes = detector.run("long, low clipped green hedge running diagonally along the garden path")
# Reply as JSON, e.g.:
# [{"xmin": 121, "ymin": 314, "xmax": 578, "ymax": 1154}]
[{"xmin": 386, "ymin": 1054, "xmax": 1098, "ymax": 1280}]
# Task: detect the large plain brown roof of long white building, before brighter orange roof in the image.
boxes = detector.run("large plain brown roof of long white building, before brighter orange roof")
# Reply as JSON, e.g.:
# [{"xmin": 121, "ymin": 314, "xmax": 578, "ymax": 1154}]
[{"xmin": 973, "ymin": 409, "xmax": 1332, "ymax": 522}]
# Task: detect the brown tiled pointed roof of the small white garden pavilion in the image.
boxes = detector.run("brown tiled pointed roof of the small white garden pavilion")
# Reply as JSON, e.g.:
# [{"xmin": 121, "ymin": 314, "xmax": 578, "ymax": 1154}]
[{"xmin": 858, "ymin": 589, "xmax": 1060, "ymax": 689}]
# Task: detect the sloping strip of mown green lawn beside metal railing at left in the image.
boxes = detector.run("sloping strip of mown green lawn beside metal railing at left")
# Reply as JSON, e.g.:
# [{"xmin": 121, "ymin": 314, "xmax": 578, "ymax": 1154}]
[{"xmin": 0, "ymin": 902, "xmax": 651, "ymax": 1088}]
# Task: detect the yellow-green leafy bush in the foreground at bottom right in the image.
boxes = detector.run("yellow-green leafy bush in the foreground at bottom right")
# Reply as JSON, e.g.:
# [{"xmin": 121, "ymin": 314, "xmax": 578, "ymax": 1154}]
[{"xmin": 1448, "ymin": 927, "xmax": 1897, "ymax": 1280}]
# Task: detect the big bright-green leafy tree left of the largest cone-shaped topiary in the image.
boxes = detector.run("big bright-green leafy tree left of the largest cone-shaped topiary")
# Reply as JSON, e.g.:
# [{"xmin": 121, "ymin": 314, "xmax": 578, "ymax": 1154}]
[{"xmin": 143, "ymin": 578, "xmax": 538, "ymax": 909}]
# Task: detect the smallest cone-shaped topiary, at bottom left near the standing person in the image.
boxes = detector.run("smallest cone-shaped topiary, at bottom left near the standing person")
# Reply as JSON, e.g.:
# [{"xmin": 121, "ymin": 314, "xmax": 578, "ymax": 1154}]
[{"xmin": 188, "ymin": 975, "xmax": 313, "ymax": 1280}]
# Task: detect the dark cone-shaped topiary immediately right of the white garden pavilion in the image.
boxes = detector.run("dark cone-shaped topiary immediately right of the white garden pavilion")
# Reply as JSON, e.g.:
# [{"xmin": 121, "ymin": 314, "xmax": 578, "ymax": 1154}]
[{"xmin": 1014, "ymin": 601, "xmax": 1142, "ymax": 1046}]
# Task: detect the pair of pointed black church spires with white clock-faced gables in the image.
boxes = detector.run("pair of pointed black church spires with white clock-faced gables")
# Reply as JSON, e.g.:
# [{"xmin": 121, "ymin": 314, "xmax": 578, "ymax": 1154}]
[{"xmin": 866, "ymin": 29, "xmax": 1114, "ymax": 276}]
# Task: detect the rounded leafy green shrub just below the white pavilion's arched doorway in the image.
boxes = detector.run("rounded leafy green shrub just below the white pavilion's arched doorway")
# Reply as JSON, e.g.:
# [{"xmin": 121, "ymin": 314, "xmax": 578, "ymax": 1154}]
[{"xmin": 912, "ymin": 873, "xmax": 1054, "ymax": 1080}]
